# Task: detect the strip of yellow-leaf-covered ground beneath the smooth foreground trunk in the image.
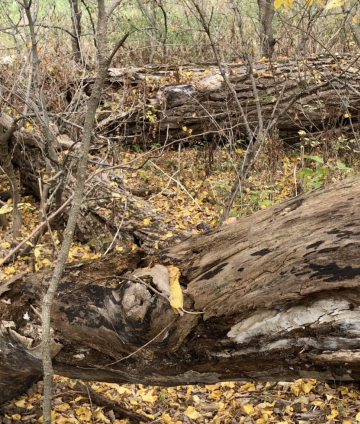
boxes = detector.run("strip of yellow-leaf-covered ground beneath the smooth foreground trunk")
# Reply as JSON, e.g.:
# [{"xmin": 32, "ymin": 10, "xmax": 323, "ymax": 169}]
[{"xmin": 2, "ymin": 376, "xmax": 360, "ymax": 424}]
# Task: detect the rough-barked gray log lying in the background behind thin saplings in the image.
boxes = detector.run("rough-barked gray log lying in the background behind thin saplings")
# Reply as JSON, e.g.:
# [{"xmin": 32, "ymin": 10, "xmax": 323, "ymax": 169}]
[{"xmin": 84, "ymin": 56, "xmax": 360, "ymax": 147}]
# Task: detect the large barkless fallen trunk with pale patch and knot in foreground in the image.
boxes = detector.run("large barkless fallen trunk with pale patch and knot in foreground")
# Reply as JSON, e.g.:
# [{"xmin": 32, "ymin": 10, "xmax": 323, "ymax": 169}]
[{"xmin": 0, "ymin": 179, "xmax": 360, "ymax": 403}]
